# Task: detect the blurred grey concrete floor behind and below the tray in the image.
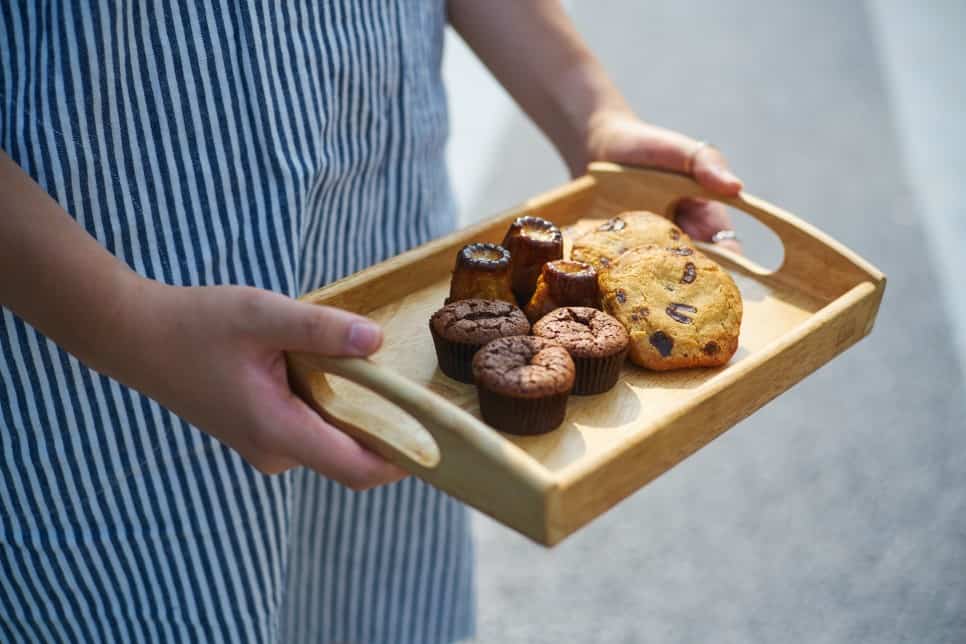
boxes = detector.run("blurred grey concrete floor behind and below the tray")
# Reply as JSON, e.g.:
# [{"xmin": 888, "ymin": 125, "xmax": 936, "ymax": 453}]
[{"xmin": 454, "ymin": 0, "xmax": 966, "ymax": 643}]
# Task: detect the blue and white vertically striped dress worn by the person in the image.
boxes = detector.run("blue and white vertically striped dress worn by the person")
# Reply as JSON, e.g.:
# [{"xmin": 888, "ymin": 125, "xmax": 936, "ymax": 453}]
[{"xmin": 0, "ymin": 0, "xmax": 474, "ymax": 643}]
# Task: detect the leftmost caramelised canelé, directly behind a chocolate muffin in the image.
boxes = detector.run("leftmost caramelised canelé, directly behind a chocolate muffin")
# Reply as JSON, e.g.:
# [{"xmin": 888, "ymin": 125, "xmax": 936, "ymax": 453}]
[{"xmin": 446, "ymin": 244, "xmax": 516, "ymax": 304}]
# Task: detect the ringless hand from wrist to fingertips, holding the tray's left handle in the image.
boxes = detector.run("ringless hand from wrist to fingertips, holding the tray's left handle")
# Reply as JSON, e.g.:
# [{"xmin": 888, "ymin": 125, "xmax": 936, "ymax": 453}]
[{"xmin": 117, "ymin": 280, "xmax": 405, "ymax": 490}]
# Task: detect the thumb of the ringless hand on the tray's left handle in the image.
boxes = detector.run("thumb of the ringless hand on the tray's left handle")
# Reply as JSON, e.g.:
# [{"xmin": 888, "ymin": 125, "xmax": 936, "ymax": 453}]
[{"xmin": 245, "ymin": 292, "xmax": 382, "ymax": 356}]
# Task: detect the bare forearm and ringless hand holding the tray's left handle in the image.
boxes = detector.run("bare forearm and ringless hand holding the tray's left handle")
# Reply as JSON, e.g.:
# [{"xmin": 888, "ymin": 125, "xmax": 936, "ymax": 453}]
[{"xmin": 0, "ymin": 151, "xmax": 401, "ymax": 488}]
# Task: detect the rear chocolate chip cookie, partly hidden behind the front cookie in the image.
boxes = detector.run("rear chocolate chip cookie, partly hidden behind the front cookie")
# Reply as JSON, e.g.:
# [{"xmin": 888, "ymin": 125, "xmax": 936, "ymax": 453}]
[{"xmin": 570, "ymin": 210, "xmax": 691, "ymax": 273}]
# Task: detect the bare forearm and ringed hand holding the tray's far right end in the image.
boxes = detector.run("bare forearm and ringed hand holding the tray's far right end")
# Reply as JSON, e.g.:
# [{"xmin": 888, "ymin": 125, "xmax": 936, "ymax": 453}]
[{"xmin": 449, "ymin": 0, "xmax": 741, "ymax": 247}]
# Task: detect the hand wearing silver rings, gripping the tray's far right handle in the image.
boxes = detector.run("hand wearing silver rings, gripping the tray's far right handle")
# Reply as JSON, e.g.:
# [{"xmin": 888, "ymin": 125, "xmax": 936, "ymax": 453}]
[{"xmin": 587, "ymin": 112, "xmax": 742, "ymax": 252}]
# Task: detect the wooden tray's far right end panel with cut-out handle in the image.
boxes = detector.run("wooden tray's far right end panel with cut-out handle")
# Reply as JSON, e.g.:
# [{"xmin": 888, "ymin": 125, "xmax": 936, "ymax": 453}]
[{"xmin": 589, "ymin": 162, "xmax": 885, "ymax": 298}]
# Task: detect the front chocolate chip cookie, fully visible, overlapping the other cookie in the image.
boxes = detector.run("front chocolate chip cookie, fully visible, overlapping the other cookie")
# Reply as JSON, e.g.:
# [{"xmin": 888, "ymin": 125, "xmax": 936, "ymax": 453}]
[{"xmin": 600, "ymin": 246, "xmax": 742, "ymax": 371}]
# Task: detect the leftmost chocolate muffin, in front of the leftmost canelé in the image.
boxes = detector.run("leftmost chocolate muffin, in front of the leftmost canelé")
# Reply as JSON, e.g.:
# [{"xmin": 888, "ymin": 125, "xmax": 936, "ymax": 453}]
[{"xmin": 429, "ymin": 299, "xmax": 530, "ymax": 383}]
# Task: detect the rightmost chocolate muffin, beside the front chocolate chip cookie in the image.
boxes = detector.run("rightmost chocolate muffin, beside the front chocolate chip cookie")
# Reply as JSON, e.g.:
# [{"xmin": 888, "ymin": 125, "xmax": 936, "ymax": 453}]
[{"xmin": 533, "ymin": 306, "xmax": 630, "ymax": 395}]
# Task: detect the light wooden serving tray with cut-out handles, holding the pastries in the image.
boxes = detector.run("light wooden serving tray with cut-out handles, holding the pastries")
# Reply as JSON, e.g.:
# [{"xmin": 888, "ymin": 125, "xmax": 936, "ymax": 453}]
[{"xmin": 289, "ymin": 163, "xmax": 885, "ymax": 545}]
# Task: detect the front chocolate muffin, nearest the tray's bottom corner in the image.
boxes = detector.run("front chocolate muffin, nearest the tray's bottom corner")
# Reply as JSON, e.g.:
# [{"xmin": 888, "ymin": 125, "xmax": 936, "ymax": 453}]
[{"xmin": 473, "ymin": 335, "xmax": 574, "ymax": 434}]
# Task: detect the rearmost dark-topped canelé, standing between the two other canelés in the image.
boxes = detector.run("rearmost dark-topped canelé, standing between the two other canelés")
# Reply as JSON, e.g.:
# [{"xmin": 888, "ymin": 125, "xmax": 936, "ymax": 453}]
[{"xmin": 502, "ymin": 216, "xmax": 563, "ymax": 306}]
